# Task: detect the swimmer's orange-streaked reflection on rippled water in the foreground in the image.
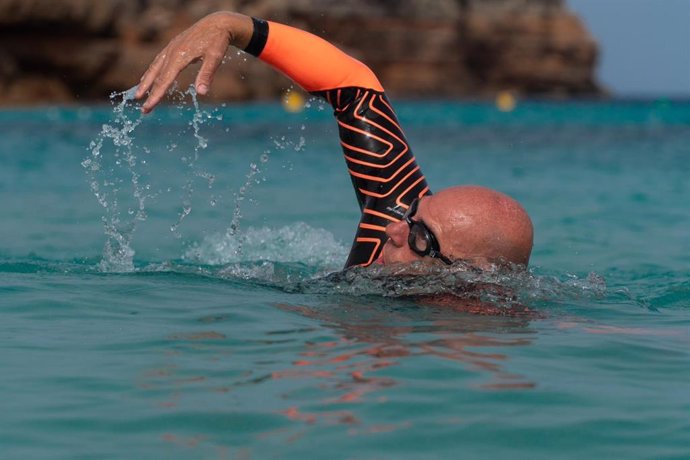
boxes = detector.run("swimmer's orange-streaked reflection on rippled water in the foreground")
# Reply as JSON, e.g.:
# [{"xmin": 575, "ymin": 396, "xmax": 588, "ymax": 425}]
[{"xmin": 138, "ymin": 296, "xmax": 537, "ymax": 445}]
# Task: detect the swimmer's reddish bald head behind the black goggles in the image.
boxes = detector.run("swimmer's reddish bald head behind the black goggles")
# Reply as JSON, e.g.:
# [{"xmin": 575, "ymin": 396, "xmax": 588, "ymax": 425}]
[{"xmin": 424, "ymin": 186, "xmax": 533, "ymax": 265}]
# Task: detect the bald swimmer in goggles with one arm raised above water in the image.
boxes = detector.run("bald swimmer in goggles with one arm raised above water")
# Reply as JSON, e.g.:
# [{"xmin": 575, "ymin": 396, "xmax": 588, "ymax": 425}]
[{"xmin": 136, "ymin": 12, "xmax": 533, "ymax": 268}]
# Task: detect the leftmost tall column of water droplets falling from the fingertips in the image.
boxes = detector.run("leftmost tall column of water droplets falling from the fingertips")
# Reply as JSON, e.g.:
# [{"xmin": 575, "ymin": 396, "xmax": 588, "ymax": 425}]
[{"xmin": 81, "ymin": 86, "xmax": 149, "ymax": 272}]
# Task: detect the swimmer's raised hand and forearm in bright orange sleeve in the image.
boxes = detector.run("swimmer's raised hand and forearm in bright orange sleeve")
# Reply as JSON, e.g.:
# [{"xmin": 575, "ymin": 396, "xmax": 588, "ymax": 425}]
[{"xmin": 136, "ymin": 12, "xmax": 383, "ymax": 113}]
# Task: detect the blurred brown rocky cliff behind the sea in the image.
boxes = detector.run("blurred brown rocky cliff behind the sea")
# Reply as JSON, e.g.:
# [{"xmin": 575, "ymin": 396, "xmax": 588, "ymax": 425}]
[{"xmin": 0, "ymin": 0, "xmax": 600, "ymax": 105}]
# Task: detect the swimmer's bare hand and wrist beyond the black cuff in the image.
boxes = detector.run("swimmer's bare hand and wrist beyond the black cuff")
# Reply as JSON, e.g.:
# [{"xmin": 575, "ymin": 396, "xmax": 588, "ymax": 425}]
[{"xmin": 135, "ymin": 12, "xmax": 254, "ymax": 113}]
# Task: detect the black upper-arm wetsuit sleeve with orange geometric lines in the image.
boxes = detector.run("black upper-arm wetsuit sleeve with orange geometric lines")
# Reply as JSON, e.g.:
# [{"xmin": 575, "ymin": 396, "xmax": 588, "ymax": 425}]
[{"xmin": 315, "ymin": 87, "xmax": 431, "ymax": 267}]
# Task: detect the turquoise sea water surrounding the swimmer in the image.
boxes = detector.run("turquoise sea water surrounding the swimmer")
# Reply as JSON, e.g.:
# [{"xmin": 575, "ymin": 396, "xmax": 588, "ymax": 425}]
[{"xmin": 0, "ymin": 98, "xmax": 690, "ymax": 459}]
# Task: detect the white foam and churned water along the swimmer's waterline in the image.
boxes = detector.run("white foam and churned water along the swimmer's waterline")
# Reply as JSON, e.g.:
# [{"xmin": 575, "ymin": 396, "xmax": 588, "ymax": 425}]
[{"xmin": 176, "ymin": 222, "xmax": 608, "ymax": 313}]
